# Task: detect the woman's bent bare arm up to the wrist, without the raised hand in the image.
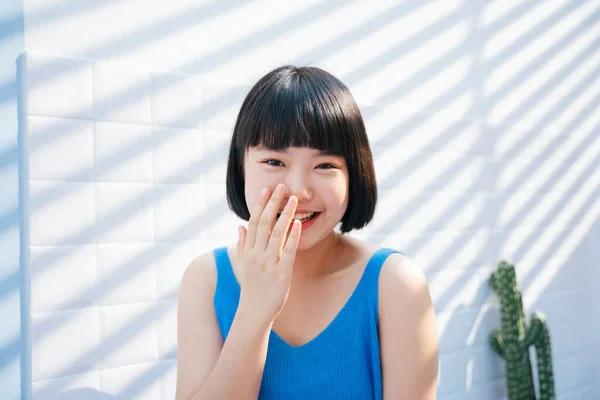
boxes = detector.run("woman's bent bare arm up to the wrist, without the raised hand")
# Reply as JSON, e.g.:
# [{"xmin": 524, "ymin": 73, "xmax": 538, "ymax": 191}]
[{"xmin": 176, "ymin": 253, "xmax": 271, "ymax": 400}]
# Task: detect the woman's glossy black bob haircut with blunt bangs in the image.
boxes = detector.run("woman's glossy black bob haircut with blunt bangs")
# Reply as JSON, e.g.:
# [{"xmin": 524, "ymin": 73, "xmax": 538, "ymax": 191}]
[{"xmin": 226, "ymin": 65, "xmax": 377, "ymax": 233}]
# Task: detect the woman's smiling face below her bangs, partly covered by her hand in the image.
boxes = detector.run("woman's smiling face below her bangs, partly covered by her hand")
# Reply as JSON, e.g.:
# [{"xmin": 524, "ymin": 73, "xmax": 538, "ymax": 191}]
[{"xmin": 244, "ymin": 147, "xmax": 349, "ymax": 250}]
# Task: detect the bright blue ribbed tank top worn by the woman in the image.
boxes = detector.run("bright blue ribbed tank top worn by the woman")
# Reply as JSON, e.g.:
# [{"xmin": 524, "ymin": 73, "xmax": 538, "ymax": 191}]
[{"xmin": 214, "ymin": 248, "xmax": 399, "ymax": 400}]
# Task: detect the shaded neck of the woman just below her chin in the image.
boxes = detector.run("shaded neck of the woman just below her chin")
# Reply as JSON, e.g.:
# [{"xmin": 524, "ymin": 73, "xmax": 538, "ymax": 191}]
[{"xmin": 293, "ymin": 231, "xmax": 343, "ymax": 281}]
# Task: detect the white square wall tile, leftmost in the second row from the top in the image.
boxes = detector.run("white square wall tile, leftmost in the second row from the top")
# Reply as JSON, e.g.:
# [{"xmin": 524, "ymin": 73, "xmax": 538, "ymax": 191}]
[{"xmin": 27, "ymin": 117, "xmax": 94, "ymax": 181}]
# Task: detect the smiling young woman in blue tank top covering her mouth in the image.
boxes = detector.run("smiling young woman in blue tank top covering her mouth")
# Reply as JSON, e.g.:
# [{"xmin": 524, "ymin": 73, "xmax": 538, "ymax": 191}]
[{"xmin": 177, "ymin": 66, "xmax": 438, "ymax": 400}]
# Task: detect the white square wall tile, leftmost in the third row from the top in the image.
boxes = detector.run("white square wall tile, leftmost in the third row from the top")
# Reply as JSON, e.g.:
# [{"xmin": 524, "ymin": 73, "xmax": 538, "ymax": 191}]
[{"xmin": 29, "ymin": 181, "xmax": 96, "ymax": 246}]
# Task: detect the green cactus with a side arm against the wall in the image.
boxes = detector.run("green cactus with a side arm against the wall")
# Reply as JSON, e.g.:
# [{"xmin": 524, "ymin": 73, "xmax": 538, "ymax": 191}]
[{"xmin": 490, "ymin": 261, "xmax": 555, "ymax": 400}]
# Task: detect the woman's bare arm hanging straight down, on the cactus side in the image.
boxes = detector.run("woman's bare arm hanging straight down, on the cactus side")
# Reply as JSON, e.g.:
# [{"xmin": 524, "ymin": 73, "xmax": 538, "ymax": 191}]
[{"xmin": 379, "ymin": 254, "xmax": 439, "ymax": 400}]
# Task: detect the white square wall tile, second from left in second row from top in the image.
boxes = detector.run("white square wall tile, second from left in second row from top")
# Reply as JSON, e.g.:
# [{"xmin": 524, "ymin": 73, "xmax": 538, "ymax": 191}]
[{"xmin": 94, "ymin": 122, "xmax": 154, "ymax": 182}]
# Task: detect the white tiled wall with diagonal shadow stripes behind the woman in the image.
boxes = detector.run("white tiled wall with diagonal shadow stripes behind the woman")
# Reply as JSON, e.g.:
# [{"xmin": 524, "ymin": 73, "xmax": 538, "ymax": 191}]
[{"xmin": 22, "ymin": 0, "xmax": 600, "ymax": 400}]
